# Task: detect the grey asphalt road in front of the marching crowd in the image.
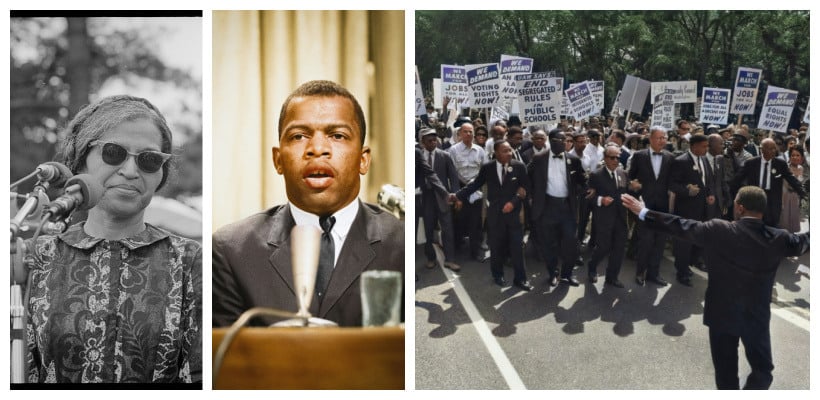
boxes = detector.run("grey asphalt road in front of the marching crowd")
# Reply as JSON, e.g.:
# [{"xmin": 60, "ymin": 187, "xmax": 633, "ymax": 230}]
[{"xmin": 415, "ymin": 227, "xmax": 810, "ymax": 390}]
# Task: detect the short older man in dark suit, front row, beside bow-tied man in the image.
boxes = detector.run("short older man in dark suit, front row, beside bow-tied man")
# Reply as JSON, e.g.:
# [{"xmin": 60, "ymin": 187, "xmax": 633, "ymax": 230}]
[{"xmin": 588, "ymin": 143, "xmax": 627, "ymax": 288}]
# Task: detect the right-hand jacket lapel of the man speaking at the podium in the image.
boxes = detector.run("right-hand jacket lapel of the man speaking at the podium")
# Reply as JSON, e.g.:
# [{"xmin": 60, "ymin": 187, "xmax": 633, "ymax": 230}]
[{"xmin": 318, "ymin": 200, "xmax": 381, "ymax": 318}]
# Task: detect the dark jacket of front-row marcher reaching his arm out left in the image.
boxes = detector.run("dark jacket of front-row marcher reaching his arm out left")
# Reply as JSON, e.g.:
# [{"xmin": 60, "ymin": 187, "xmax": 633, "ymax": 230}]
[{"xmin": 456, "ymin": 160, "xmax": 530, "ymax": 229}]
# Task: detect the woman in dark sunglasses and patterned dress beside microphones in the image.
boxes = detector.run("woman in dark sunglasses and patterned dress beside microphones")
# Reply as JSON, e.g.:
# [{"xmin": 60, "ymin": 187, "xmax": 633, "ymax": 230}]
[{"xmin": 27, "ymin": 96, "xmax": 202, "ymax": 383}]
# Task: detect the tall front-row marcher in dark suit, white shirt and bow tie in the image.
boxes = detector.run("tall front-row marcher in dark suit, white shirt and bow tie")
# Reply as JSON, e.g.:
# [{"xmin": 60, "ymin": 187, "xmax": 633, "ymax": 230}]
[{"xmin": 627, "ymin": 126, "xmax": 673, "ymax": 286}]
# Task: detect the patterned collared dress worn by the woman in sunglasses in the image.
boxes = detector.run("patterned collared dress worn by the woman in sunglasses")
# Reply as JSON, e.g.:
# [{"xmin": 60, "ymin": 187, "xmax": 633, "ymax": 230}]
[{"xmin": 26, "ymin": 223, "xmax": 202, "ymax": 383}]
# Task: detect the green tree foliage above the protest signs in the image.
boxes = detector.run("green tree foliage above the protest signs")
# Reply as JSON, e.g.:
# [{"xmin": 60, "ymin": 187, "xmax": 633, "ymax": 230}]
[{"xmin": 416, "ymin": 10, "xmax": 810, "ymax": 124}]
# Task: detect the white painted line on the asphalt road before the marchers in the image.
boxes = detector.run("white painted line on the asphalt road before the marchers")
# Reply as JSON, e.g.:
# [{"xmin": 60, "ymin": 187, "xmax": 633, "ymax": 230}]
[{"xmin": 442, "ymin": 268, "xmax": 527, "ymax": 389}]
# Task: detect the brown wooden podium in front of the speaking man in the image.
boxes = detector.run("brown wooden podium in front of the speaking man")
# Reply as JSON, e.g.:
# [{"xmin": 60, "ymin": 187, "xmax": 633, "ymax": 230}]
[{"xmin": 212, "ymin": 328, "xmax": 404, "ymax": 390}]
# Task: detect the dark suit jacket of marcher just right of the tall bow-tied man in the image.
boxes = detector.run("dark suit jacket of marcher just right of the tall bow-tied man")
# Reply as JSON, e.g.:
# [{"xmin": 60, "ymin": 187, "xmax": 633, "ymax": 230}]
[{"xmin": 669, "ymin": 152, "xmax": 715, "ymax": 221}]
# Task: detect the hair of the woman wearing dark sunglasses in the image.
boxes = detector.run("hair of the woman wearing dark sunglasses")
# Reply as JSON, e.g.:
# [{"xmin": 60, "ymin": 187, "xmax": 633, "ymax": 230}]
[{"xmin": 57, "ymin": 95, "xmax": 173, "ymax": 190}]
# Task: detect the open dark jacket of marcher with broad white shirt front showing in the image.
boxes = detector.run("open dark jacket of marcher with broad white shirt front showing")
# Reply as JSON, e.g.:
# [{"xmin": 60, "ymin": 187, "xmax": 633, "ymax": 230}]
[{"xmin": 527, "ymin": 151, "xmax": 587, "ymax": 221}]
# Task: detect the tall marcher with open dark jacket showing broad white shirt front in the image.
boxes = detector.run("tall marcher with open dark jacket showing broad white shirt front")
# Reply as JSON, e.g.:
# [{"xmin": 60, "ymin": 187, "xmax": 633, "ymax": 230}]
[{"xmin": 527, "ymin": 128, "xmax": 587, "ymax": 286}]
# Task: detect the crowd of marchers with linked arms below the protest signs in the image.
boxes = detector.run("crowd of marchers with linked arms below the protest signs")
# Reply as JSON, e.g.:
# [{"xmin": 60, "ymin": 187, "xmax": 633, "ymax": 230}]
[{"xmin": 416, "ymin": 99, "xmax": 809, "ymax": 291}]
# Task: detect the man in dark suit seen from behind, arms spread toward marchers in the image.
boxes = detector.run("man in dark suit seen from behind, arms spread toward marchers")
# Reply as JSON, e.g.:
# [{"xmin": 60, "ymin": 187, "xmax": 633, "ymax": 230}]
[{"xmin": 623, "ymin": 186, "xmax": 809, "ymax": 389}]
